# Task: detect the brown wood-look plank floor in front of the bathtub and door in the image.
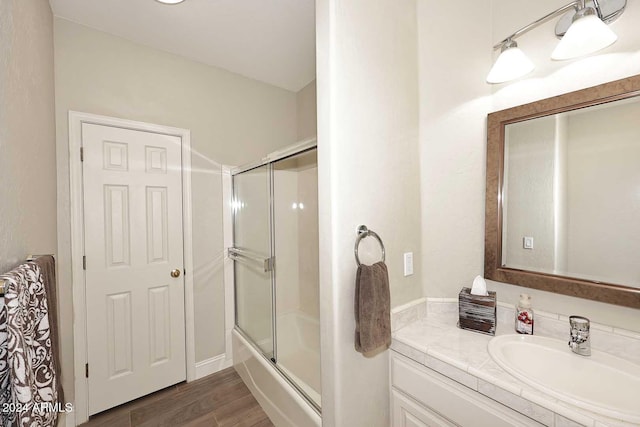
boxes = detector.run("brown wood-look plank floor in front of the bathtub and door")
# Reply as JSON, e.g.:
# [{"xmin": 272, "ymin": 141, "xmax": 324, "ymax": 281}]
[{"xmin": 82, "ymin": 368, "xmax": 273, "ymax": 427}]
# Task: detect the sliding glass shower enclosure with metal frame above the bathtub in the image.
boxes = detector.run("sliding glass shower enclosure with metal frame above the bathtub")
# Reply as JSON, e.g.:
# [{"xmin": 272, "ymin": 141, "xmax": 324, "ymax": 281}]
[{"xmin": 229, "ymin": 141, "xmax": 321, "ymax": 425}]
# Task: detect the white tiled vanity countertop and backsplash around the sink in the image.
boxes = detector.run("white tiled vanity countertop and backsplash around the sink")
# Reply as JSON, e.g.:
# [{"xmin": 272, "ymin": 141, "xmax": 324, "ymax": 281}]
[{"xmin": 391, "ymin": 299, "xmax": 640, "ymax": 427}]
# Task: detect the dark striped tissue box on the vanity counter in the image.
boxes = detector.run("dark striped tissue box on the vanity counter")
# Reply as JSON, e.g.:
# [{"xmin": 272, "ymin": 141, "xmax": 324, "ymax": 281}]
[{"xmin": 458, "ymin": 288, "xmax": 496, "ymax": 335}]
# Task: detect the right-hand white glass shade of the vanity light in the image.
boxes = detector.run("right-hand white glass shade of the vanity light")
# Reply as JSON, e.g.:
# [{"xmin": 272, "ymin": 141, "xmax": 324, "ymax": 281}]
[{"xmin": 551, "ymin": 15, "xmax": 618, "ymax": 61}]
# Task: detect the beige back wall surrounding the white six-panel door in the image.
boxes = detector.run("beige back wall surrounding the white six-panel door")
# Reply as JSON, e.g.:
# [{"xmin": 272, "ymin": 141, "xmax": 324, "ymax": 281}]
[{"xmin": 55, "ymin": 18, "xmax": 297, "ymax": 408}]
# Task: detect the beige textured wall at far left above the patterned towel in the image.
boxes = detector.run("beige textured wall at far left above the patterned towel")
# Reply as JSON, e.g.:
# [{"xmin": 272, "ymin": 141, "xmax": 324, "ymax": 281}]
[{"xmin": 0, "ymin": 0, "xmax": 56, "ymax": 273}]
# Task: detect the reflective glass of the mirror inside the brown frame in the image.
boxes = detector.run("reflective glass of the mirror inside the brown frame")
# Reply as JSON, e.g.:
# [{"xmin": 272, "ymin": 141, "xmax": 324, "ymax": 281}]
[{"xmin": 501, "ymin": 97, "xmax": 640, "ymax": 288}]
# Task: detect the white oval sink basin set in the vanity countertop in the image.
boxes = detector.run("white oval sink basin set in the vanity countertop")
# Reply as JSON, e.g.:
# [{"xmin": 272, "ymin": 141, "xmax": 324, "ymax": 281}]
[{"xmin": 489, "ymin": 335, "xmax": 640, "ymax": 423}]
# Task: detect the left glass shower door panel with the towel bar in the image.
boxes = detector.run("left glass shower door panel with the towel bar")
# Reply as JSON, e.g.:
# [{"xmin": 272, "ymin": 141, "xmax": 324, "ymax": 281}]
[{"xmin": 235, "ymin": 165, "xmax": 274, "ymax": 359}]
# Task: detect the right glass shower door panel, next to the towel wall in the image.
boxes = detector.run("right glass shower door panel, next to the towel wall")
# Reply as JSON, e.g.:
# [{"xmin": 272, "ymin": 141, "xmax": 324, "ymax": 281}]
[{"xmin": 272, "ymin": 149, "xmax": 321, "ymax": 409}]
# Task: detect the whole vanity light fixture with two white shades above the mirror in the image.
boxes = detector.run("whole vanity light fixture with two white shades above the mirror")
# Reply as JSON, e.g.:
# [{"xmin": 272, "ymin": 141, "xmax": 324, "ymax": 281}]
[{"xmin": 487, "ymin": 0, "xmax": 627, "ymax": 83}]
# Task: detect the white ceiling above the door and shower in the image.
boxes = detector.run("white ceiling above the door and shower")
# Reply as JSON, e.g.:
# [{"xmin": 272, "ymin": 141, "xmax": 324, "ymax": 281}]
[{"xmin": 49, "ymin": 0, "xmax": 316, "ymax": 92}]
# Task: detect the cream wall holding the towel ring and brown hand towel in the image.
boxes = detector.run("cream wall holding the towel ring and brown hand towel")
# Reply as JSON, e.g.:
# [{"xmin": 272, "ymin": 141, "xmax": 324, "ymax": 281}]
[{"xmin": 316, "ymin": 0, "xmax": 422, "ymax": 427}]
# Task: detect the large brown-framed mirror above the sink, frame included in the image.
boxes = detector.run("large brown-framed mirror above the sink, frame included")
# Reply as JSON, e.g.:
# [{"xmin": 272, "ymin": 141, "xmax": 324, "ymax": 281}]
[{"xmin": 485, "ymin": 75, "xmax": 640, "ymax": 308}]
